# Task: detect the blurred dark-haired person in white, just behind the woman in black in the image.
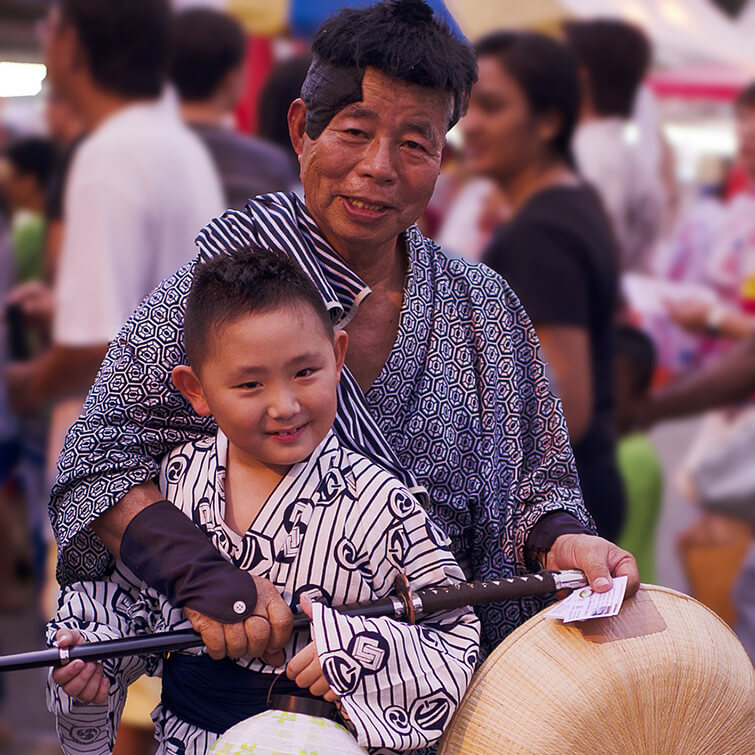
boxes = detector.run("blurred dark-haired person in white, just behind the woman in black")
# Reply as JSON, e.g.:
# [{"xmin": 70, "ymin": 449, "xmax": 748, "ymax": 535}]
[{"xmin": 564, "ymin": 19, "xmax": 665, "ymax": 271}]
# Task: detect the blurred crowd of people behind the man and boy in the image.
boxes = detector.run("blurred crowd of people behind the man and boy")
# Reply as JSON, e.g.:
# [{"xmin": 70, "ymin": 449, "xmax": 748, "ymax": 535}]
[{"xmin": 0, "ymin": 2, "xmax": 755, "ymax": 753}]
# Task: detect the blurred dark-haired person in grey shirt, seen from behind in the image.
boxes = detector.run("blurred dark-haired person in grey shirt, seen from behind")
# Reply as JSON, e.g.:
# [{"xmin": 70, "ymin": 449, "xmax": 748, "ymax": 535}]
[{"xmin": 171, "ymin": 8, "xmax": 299, "ymax": 209}]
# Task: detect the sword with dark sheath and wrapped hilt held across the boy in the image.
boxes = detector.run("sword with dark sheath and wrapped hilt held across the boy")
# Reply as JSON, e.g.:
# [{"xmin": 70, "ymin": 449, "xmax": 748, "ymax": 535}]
[{"xmin": 0, "ymin": 570, "xmax": 588, "ymax": 672}]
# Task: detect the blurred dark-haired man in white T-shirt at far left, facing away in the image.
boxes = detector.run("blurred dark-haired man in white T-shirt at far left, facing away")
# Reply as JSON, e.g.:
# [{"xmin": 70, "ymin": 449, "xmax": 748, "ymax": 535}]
[{"xmin": 5, "ymin": 0, "xmax": 224, "ymax": 753}]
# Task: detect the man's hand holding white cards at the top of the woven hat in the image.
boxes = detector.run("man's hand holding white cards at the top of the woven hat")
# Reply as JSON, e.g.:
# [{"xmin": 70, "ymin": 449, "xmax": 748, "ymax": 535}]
[{"xmin": 546, "ymin": 535, "xmax": 640, "ymax": 598}]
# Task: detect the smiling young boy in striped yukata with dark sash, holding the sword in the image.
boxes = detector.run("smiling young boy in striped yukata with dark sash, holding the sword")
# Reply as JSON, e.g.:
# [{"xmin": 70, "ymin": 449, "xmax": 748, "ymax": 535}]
[{"xmin": 48, "ymin": 250, "xmax": 479, "ymax": 755}]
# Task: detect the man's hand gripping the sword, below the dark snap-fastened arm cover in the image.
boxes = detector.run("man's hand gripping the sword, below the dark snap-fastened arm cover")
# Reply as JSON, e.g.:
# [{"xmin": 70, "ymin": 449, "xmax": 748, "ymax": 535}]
[{"xmin": 184, "ymin": 575, "xmax": 294, "ymax": 666}]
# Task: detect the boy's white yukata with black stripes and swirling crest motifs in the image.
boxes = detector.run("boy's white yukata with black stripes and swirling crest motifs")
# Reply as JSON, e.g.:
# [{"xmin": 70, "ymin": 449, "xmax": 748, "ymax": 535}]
[{"xmin": 48, "ymin": 431, "xmax": 479, "ymax": 755}]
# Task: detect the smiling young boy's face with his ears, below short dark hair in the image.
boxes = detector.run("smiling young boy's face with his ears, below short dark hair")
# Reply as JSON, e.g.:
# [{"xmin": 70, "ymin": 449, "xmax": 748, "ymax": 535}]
[{"xmin": 179, "ymin": 302, "xmax": 347, "ymax": 474}]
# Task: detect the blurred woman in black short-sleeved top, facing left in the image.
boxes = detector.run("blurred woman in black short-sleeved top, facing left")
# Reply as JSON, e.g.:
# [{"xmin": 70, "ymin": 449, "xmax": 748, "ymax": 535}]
[{"xmin": 463, "ymin": 32, "xmax": 624, "ymax": 539}]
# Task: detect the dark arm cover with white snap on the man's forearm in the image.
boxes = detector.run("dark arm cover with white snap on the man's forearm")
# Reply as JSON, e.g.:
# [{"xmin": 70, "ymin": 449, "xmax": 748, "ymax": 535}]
[{"xmin": 121, "ymin": 501, "xmax": 257, "ymax": 624}]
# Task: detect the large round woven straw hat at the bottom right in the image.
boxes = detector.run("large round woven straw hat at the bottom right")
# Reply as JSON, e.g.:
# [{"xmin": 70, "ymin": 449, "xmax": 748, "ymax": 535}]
[{"xmin": 439, "ymin": 585, "xmax": 755, "ymax": 755}]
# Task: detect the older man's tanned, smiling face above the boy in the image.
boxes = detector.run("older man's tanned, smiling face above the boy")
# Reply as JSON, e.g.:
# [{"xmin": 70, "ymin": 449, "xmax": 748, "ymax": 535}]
[{"xmin": 297, "ymin": 68, "xmax": 449, "ymax": 260}]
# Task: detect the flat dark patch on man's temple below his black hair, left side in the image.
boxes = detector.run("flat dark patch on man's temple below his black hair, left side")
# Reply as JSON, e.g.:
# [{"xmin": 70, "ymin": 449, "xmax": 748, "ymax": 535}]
[{"xmin": 301, "ymin": 58, "xmax": 453, "ymax": 139}]
